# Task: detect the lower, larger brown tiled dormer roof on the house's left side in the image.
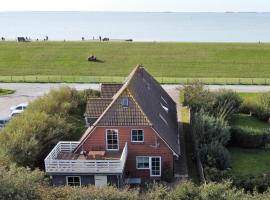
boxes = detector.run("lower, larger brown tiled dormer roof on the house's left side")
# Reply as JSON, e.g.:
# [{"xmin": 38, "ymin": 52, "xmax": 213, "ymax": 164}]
[{"xmin": 85, "ymin": 98, "xmax": 112, "ymax": 118}]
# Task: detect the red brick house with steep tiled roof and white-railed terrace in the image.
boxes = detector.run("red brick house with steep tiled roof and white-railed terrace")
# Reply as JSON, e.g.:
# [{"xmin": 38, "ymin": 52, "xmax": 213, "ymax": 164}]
[{"xmin": 45, "ymin": 66, "xmax": 180, "ymax": 186}]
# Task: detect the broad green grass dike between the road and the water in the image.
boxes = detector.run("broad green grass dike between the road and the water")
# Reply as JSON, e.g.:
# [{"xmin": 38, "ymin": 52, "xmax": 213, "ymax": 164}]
[{"xmin": 0, "ymin": 42, "xmax": 270, "ymax": 84}]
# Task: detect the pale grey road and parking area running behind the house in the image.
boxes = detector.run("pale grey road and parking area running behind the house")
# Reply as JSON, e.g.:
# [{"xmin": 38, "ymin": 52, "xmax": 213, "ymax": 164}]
[{"xmin": 0, "ymin": 83, "xmax": 270, "ymax": 117}]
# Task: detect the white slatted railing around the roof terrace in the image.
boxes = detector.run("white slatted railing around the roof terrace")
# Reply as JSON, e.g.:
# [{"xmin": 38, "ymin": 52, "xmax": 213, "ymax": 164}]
[{"xmin": 45, "ymin": 142, "xmax": 128, "ymax": 173}]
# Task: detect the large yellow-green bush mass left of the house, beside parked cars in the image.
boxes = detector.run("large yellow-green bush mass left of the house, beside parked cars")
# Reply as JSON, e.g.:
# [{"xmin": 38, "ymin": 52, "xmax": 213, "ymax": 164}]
[{"xmin": 0, "ymin": 87, "xmax": 99, "ymax": 168}]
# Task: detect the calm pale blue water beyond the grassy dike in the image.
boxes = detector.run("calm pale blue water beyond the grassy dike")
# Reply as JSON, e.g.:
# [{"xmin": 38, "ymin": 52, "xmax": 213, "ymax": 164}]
[{"xmin": 0, "ymin": 12, "xmax": 270, "ymax": 42}]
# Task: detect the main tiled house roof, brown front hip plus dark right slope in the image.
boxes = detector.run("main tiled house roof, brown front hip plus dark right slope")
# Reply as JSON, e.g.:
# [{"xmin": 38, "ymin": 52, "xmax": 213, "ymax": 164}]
[{"xmin": 77, "ymin": 66, "xmax": 180, "ymax": 155}]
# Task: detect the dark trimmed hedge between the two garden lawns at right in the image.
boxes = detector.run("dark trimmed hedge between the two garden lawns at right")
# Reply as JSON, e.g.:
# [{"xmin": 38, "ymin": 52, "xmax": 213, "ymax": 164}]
[{"xmin": 230, "ymin": 127, "xmax": 270, "ymax": 148}]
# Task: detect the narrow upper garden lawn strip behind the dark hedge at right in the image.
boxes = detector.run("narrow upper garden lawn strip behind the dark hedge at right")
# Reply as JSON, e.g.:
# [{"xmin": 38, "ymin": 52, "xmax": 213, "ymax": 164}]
[{"xmin": 230, "ymin": 113, "xmax": 270, "ymax": 129}]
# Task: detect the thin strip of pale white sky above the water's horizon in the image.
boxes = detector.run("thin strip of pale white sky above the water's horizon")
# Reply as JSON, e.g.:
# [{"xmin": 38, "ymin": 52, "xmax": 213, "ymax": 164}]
[{"xmin": 0, "ymin": 0, "xmax": 270, "ymax": 12}]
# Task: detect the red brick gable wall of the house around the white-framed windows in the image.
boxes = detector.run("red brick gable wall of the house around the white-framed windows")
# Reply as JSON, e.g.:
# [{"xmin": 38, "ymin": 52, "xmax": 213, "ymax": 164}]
[{"xmin": 79, "ymin": 127, "xmax": 173, "ymax": 179}]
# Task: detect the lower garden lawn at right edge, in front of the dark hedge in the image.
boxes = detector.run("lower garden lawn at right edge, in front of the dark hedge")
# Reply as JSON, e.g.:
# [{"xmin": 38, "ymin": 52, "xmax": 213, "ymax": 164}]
[{"xmin": 229, "ymin": 148, "xmax": 270, "ymax": 176}]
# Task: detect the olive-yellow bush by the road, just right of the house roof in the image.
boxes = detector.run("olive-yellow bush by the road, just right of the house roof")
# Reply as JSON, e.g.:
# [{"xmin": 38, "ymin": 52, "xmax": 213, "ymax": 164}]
[{"xmin": 183, "ymin": 81, "xmax": 214, "ymax": 112}]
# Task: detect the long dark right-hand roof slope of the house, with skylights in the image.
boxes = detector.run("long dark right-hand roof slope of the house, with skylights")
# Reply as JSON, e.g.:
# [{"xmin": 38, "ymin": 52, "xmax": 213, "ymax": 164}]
[{"xmin": 127, "ymin": 67, "xmax": 180, "ymax": 154}]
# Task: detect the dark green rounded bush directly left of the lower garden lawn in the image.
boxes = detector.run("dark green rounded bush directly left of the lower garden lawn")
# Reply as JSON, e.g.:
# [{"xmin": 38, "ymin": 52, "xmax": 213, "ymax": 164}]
[{"xmin": 199, "ymin": 143, "xmax": 231, "ymax": 170}]
